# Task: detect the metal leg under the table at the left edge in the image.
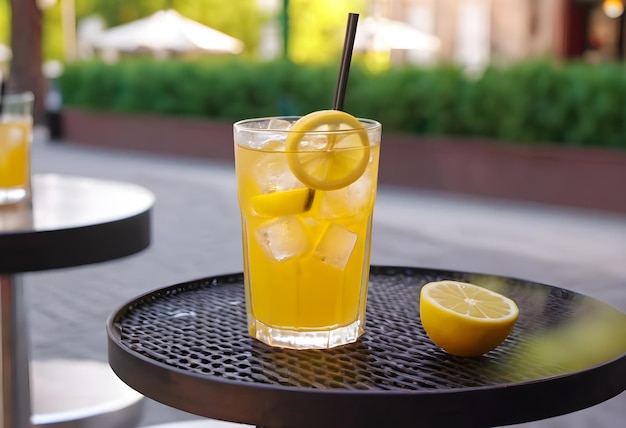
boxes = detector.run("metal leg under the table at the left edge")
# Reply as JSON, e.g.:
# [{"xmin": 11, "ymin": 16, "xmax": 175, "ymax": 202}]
[{"xmin": 0, "ymin": 274, "xmax": 31, "ymax": 428}]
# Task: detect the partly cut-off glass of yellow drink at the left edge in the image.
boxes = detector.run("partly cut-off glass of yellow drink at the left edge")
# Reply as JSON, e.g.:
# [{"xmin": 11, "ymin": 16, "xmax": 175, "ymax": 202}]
[{"xmin": 0, "ymin": 92, "xmax": 35, "ymax": 205}]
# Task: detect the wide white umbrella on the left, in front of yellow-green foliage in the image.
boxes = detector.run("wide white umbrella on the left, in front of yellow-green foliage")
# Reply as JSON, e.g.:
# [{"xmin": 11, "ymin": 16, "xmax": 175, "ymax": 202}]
[{"xmin": 92, "ymin": 9, "xmax": 243, "ymax": 54}]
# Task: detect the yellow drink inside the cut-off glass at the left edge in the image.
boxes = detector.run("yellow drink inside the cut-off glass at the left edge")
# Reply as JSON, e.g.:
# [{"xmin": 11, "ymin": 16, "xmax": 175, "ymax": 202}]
[{"xmin": 0, "ymin": 119, "xmax": 32, "ymax": 188}]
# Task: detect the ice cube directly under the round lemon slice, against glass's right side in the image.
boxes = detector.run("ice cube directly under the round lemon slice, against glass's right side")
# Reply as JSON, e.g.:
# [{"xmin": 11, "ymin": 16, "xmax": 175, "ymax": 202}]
[{"xmin": 320, "ymin": 171, "xmax": 373, "ymax": 218}]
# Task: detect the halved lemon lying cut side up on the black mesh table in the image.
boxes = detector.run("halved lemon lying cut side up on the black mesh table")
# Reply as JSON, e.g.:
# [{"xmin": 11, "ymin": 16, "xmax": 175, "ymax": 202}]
[{"xmin": 420, "ymin": 280, "xmax": 519, "ymax": 357}]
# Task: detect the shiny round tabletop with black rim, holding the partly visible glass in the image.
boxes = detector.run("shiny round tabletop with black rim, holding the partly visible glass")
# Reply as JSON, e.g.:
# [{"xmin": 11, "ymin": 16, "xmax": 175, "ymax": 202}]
[{"xmin": 0, "ymin": 174, "xmax": 154, "ymax": 274}]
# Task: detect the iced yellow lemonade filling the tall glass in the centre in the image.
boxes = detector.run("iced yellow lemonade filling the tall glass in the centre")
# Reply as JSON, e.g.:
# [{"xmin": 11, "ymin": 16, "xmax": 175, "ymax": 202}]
[{"xmin": 235, "ymin": 112, "xmax": 380, "ymax": 348}]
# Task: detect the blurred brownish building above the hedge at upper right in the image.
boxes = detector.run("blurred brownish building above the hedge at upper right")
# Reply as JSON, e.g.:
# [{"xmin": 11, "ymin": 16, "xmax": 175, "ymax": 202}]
[{"xmin": 382, "ymin": 0, "xmax": 626, "ymax": 68}]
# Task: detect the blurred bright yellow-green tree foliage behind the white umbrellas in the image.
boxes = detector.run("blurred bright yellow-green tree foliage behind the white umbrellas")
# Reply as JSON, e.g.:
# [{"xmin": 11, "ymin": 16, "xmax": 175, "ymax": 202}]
[{"xmin": 0, "ymin": 0, "xmax": 368, "ymax": 63}]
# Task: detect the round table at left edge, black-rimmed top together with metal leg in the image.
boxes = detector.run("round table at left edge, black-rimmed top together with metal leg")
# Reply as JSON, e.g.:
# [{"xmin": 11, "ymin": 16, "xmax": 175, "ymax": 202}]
[{"xmin": 0, "ymin": 174, "xmax": 154, "ymax": 428}]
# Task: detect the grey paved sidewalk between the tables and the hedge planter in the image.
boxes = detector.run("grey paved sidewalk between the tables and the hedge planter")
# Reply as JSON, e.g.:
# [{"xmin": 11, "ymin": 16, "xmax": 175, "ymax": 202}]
[{"xmin": 25, "ymin": 132, "xmax": 626, "ymax": 428}]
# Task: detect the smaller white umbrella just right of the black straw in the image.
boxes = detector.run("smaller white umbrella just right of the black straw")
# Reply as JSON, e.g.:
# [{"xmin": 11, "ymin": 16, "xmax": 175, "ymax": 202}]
[{"xmin": 354, "ymin": 16, "xmax": 441, "ymax": 52}]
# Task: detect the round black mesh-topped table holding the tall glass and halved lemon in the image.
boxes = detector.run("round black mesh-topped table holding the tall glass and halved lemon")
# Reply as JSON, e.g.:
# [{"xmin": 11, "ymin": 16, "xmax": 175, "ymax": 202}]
[{"xmin": 107, "ymin": 266, "xmax": 626, "ymax": 428}]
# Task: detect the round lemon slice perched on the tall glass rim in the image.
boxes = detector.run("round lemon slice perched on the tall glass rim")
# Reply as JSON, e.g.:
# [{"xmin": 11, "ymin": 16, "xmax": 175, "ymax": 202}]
[{"xmin": 286, "ymin": 110, "xmax": 370, "ymax": 190}]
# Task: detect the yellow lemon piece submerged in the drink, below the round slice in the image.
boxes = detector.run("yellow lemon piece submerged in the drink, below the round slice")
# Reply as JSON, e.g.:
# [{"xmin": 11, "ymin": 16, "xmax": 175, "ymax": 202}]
[{"xmin": 251, "ymin": 188, "xmax": 314, "ymax": 217}]
